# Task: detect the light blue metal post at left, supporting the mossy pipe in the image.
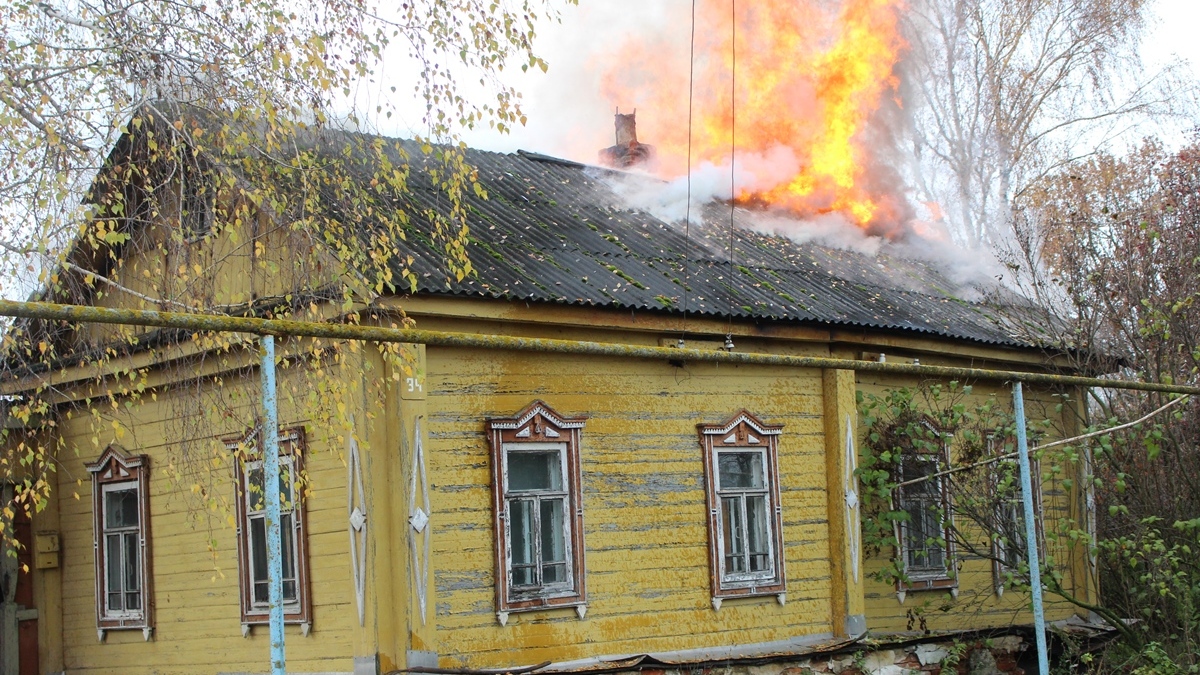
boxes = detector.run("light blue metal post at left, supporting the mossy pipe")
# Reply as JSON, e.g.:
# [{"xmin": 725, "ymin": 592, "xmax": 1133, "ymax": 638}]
[{"xmin": 262, "ymin": 335, "xmax": 286, "ymax": 675}]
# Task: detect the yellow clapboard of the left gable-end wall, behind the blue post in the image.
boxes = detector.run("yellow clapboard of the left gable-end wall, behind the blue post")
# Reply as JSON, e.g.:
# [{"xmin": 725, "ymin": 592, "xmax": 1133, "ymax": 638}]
[{"xmin": 56, "ymin": 365, "xmax": 359, "ymax": 675}]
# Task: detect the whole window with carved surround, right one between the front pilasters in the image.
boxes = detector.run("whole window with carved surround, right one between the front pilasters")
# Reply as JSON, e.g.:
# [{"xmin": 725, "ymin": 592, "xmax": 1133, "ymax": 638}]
[{"xmin": 697, "ymin": 411, "xmax": 785, "ymax": 609}]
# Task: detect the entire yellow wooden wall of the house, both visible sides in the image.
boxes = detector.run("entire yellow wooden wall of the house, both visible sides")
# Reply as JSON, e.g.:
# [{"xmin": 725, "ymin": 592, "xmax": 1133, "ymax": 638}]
[{"xmin": 21, "ymin": 295, "xmax": 1099, "ymax": 673}]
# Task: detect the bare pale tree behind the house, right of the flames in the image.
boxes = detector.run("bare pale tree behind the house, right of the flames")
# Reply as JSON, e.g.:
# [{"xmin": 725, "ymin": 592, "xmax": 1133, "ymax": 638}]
[{"xmin": 906, "ymin": 0, "xmax": 1178, "ymax": 247}]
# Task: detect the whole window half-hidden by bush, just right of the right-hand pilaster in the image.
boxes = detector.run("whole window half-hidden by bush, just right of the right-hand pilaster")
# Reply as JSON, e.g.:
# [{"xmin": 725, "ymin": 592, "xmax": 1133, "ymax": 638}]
[{"xmin": 895, "ymin": 423, "xmax": 958, "ymax": 593}]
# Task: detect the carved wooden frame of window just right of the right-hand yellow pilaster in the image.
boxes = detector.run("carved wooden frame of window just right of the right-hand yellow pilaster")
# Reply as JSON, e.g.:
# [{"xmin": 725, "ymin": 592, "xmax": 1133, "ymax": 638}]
[{"xmin": 893, "ymin": 422, "xmax": 959, "ymax": 602}]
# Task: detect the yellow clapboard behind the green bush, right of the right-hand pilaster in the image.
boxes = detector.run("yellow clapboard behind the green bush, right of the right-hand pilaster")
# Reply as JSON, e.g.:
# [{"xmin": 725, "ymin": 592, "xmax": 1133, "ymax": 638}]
[{"xmin": 858, "ymin": 374, "xmax": 1075, "ymax": 632}]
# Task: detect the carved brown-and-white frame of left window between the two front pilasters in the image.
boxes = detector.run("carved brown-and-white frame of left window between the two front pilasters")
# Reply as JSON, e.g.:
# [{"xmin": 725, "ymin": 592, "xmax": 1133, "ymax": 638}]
[{"xmin": 486, "ymin": 401, "xmax": 587, "ymax": 626}]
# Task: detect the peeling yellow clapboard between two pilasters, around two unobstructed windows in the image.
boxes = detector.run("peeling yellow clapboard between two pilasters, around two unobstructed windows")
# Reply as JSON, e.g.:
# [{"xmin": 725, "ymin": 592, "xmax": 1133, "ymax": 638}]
[{"xmin": 428, "ymin": 348, "xmax": 829, "ymax": 667}]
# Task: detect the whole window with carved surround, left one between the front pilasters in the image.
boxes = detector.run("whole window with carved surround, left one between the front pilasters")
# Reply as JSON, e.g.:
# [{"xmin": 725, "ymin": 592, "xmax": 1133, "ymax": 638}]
[{"xmin": 487, "ymin": 401, "xmax": 587, "ymax": 625}]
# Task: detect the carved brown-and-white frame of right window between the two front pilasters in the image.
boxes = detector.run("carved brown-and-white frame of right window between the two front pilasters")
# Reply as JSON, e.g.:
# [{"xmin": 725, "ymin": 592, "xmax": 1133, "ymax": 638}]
[{"xmin": 696, "ymin": 410, "xmax": 787, "ymax": 609}]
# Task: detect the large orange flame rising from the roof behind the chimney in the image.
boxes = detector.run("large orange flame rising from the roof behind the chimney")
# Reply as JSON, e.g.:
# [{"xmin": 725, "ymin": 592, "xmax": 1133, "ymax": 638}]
[{"xmin": 604, "ymin": 0, "xmax": 907, "ymax": 233}]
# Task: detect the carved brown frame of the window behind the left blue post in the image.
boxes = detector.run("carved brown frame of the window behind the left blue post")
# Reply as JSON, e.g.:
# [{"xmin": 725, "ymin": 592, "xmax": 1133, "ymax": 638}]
[{"xmin": 226, "ymin": 426, "xmax": 312, "ymax": 635}]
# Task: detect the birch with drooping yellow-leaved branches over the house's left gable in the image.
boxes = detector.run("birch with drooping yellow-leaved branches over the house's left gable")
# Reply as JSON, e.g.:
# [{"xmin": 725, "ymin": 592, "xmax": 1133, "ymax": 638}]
[{"xmin": 0, "ymin": 0, "xmax": 574, "ymax": 534}]
